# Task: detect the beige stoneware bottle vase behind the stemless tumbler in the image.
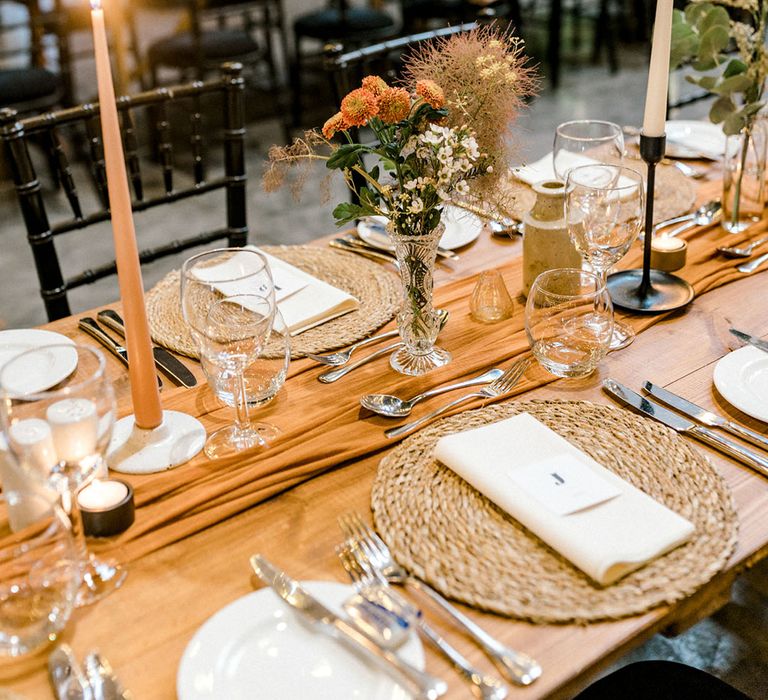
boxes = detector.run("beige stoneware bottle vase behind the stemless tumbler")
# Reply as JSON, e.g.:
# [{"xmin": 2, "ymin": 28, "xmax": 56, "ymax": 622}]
[{"xmin": 523, "ymin": 180, "xmax": 581, "ymax": 296}]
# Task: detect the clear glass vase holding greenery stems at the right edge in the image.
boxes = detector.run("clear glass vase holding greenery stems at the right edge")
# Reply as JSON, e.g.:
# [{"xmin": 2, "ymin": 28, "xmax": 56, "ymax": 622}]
[{"xmin": 723, "ymin": 120, "xmax": 768, "ymax": 233}]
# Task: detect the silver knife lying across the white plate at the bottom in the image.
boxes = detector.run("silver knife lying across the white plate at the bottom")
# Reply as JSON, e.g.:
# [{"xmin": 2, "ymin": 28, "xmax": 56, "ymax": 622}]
[{"xmin": 251, "ymin": 554, "xmax": 448, "ymax": 700}]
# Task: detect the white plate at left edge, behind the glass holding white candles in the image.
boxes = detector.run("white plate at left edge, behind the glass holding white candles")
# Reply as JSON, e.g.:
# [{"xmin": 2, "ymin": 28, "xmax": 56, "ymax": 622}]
[{"xmin": 0, "ymin": 328, "xmax": 77, "ymax": 394}]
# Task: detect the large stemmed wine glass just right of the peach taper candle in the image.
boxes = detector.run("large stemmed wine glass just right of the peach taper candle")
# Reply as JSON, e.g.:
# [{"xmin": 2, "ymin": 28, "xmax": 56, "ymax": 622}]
[{"xmin": 181, "ymin": 248, "xmax": 277, "ymax": 459}]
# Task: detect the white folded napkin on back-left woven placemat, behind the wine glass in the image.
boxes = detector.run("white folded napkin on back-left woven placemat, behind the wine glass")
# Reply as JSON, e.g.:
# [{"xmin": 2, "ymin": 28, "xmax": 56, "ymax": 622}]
[{"xmin": 195, "ymin": 246, "xmax": 360, "ymax": 335}]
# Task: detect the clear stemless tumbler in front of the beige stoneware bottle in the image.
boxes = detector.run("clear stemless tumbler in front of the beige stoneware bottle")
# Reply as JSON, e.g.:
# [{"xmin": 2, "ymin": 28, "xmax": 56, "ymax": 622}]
[{"xmin": 525, "ymin": 268, "xmax": 613, "ymax": 377}]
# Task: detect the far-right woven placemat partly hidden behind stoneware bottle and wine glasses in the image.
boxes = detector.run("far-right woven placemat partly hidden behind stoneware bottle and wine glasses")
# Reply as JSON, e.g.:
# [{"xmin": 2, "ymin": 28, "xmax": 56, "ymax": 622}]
[{"xmin": 502, "ymin": 158, "xmax": 696, "ymax": 222}]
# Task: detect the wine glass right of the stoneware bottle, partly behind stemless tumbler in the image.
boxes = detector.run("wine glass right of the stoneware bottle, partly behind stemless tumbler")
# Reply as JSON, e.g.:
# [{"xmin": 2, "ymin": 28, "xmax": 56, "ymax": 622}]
[{"xmin": 565, "ymin": 164, "xmax": 643, "ymax": 350}]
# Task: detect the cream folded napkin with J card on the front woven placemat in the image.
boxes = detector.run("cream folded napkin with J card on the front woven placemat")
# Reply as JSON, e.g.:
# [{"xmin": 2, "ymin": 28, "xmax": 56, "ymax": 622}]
[{"xmin": 435, "ymin": 413, "xmax": 694, "ymax": 586}]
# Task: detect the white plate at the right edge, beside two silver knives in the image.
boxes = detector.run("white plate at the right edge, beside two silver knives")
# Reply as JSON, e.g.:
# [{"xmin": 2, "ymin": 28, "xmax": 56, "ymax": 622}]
[{"xmin": 713, "ymin": 345, "xmax": 768, "ymax": 423}]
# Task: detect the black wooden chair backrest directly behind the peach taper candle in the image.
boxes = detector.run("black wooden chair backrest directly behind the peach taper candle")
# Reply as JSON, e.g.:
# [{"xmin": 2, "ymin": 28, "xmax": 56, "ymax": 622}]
[{"xmin": 0, "ymin": 64, "xmax": 248, "ymax": 320}]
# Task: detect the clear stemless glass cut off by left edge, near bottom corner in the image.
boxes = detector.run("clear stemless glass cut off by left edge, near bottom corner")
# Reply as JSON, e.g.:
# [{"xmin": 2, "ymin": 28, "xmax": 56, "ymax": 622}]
[{"xmin": 0, "ymin": 491, "xmax": 80, "ymax": 657}]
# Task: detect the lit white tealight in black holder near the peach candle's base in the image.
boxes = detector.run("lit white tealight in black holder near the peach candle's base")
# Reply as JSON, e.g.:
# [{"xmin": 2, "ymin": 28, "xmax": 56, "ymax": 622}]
[{"xmin": 77, "ymin": 479, "xmax": 134, "ymax": 537}]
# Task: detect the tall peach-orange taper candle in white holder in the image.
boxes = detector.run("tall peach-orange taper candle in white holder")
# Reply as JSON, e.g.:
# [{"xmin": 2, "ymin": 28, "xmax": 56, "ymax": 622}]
[{"xmin": 91, "ymin": 0, "xmax": 163, "ymax": 429}]
